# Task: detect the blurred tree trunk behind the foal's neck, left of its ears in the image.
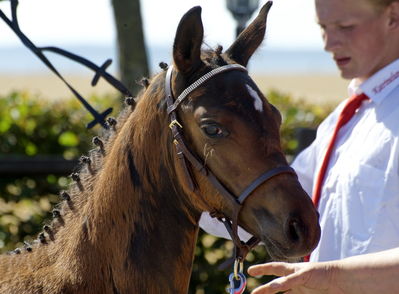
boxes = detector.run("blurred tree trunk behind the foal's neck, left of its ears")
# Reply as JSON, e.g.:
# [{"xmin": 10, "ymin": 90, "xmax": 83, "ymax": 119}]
[{"xmin": 112, "ymin": 0, "xmax": 149, "ymax": 93}]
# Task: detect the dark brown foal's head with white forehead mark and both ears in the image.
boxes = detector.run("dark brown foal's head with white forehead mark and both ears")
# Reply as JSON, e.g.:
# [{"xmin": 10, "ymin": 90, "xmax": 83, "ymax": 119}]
[{"xmin": 164, "ymin": 4, "xmax": 320, "ymax": 259}]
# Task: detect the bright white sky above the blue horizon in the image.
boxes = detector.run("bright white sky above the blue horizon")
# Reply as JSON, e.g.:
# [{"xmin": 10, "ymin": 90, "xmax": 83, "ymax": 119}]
[{"xmin": 0, "ymin": 0, "xmax": 322, "ymax": 50}]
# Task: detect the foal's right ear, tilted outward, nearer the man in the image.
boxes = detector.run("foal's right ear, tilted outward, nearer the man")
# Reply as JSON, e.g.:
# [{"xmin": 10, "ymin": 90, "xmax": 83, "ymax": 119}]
[{"xmin": 225, "ymin": 1, "xmax": 273, "ymax": 66}]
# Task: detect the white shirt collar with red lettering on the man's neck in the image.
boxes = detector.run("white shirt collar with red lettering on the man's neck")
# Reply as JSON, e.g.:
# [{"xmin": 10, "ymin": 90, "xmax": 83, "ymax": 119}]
[{"xmin": 348, "ymin": 59, "xmax": 399, "ymax": 104}]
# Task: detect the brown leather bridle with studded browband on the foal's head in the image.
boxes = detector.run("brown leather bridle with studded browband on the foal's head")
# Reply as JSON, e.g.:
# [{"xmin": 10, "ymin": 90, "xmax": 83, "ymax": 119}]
[{"xmin": 165, "ymin": 64, "xmax": 296, "ymax": 262}]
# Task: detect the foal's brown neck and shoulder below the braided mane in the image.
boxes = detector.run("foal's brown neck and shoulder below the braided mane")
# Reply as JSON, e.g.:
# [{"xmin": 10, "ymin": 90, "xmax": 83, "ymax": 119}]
[{"xmin": 0, "ymin": 88, "xmax": 200, "ymax": 294}]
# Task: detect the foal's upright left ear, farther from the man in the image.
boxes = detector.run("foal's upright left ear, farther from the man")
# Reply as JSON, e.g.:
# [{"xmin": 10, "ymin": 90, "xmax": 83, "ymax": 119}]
[{"xmin": 173, "ymin": 6, "xmax": 204, "ymax": 74}]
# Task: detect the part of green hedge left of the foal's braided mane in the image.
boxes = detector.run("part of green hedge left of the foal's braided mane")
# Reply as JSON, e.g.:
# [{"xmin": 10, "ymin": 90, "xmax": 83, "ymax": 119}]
[{"xmin": 0, "ymin": 92, "xmax": 118, "ymax": 252}]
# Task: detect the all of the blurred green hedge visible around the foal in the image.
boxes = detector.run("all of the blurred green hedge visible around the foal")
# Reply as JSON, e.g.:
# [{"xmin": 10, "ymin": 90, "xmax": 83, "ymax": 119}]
[{"xmin": 0, "ymin": 91, "xmax": 329, "ymax": 294}]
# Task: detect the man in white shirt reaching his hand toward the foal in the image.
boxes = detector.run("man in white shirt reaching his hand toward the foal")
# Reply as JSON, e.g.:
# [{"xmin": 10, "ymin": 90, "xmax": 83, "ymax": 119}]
[{"xmin": 249, "ymin": 0, "xmax": 399, "ymax": 294}]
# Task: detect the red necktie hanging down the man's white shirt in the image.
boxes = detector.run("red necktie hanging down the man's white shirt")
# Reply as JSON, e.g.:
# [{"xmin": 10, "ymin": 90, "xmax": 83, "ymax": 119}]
[{"xmin": 305, "ymin": 94, "xmax": 369, "ymax": 261}]
